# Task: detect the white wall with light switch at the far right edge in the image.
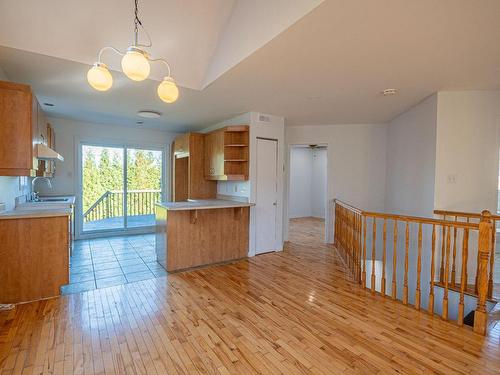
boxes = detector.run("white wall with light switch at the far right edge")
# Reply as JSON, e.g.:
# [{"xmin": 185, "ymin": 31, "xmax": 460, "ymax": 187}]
[{"xmin": 434, "ymin": 91, "xmax": 500, "ymax": 212}]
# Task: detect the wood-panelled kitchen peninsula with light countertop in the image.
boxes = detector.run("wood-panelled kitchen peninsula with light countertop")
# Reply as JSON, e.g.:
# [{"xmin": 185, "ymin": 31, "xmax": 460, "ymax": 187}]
[{"xmin": 156, "ymin": 199, "xmax": 252, "ymax": 272}]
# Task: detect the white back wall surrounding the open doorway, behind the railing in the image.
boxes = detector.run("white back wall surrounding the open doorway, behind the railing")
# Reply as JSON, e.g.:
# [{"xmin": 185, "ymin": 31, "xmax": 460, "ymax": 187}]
[{"xmin": 285, "ymin": 124, "xmax": 387, "ymax": 241}]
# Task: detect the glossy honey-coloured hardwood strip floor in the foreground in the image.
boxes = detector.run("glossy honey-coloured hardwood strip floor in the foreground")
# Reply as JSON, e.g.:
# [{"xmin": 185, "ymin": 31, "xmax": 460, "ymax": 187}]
[{"xmin": 0, "ymin": 219, "xmax": 500, "ymax": 374}]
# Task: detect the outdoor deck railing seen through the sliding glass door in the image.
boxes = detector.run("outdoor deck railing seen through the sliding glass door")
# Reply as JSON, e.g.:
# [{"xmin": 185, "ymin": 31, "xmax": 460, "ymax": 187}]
[{"xmin": 83, "ymin": 190, "xmax": 161, "ymax": 222}]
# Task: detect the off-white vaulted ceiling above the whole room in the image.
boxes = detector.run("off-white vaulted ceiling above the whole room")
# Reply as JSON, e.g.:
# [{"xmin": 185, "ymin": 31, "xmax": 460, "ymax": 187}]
[{"xmin": 0, "ymin": 0, "xmax": 500, "ymax": 131}]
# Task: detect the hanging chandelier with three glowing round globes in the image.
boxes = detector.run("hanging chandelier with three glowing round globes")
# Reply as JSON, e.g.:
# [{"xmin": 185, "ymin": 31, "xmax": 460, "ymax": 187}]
[{"xmin": 87, "ymin": 0, "xmax": 179, "ymax": 103}]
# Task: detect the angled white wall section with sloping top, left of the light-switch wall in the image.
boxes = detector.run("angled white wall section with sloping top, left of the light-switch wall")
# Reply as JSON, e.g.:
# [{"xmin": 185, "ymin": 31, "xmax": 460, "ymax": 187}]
[{"xmin": 385, "ymin": 95, "xmax": 437, "ymax": 217}]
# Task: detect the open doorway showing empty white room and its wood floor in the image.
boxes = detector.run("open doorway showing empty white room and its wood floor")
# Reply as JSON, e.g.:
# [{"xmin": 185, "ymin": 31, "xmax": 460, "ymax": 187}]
[{"xmin": 288, "ymin": 144, "xmax": 328, "ymax": 242}]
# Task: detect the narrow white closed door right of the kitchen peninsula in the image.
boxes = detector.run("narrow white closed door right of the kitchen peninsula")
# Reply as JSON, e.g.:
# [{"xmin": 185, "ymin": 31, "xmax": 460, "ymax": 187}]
[{"xmin": 255, "ymin": 139, "xmax": 278, "ymax": 254}]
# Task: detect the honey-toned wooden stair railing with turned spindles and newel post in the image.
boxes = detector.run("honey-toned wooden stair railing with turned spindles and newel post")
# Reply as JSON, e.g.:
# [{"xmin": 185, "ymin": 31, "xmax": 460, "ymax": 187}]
[{"xmin": 334, "ymin": 200, "xmax": 493, "ymax": 335}]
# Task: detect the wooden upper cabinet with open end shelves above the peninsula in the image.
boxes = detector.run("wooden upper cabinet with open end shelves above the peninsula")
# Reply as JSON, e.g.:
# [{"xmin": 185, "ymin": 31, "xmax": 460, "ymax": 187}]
[{"xmin": 205, "ymin": 125, "xmax": 249, "ymax": 181}]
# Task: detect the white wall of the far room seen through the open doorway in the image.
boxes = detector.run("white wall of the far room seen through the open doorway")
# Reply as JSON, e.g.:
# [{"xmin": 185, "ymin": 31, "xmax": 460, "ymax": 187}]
[{"xmin": 289, "ymin": 147, "xmax": 327, "ymax": 218}]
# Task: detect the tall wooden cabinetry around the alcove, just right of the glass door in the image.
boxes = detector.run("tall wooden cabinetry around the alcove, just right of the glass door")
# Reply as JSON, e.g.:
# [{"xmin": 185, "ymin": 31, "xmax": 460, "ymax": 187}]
[{"xmin": 172, "ymin": 133, "xmax": 217, "ymax": 202}]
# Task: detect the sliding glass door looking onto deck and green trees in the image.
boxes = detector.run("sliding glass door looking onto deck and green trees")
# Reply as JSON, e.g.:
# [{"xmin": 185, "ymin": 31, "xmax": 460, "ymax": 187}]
[{"xmin": 80, "ymin": 143, "xmax": 164, "ymax": 235}]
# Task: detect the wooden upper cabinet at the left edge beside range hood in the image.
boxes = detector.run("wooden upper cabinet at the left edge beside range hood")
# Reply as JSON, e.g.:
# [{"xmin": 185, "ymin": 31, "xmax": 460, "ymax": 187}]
[{"xmin": 0, "ymin": 81, "xmax": 41, "ymax": 176}]
